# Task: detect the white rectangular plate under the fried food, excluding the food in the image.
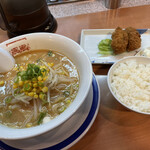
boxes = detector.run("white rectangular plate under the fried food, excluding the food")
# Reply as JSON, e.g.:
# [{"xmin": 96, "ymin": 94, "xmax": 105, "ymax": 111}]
[{"xmin": 80, "ymin": 29, "xmax": 150, "ymax": 64}]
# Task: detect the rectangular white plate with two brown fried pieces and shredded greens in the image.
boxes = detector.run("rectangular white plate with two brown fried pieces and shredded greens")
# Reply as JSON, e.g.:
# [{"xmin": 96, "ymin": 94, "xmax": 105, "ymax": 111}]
[{"xmin": 80, "ymin": 27, "xmax": 150, "ymax": 64}]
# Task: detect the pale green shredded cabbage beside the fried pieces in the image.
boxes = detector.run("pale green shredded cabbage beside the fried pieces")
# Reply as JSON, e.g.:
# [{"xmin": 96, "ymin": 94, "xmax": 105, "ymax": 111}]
[{"xmin": 98, "ymin": 39, "xmax": 113, "ymax": 55}]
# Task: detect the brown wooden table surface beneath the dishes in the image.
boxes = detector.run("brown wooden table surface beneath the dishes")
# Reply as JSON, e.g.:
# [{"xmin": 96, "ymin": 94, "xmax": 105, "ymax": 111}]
[{"xmin": 0, "ymin": 5, "xmax": 150, "ymax": 150}]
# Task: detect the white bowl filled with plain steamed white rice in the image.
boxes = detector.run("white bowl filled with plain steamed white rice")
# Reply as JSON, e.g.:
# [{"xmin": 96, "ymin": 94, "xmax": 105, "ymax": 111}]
[{"xmin": 107, "ymin": 56, "xmax": 150, "ymax": 114}]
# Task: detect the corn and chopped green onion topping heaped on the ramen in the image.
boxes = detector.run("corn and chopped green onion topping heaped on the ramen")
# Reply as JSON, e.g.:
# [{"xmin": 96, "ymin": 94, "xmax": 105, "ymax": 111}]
[{"xmin": 13, "ymin": 64, "xmax": 49, "ymax": 102}]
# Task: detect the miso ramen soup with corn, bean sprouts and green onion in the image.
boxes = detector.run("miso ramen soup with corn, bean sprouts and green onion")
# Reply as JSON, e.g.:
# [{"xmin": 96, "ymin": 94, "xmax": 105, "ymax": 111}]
[{"xmin": 0, "ymin": 50, "xmax": 79, "ymax": 128}]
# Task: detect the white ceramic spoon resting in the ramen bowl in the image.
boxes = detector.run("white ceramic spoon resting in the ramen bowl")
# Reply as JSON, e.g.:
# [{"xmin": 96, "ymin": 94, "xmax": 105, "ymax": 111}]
[{"xmin": 0, "ymin": 48, "xmax": 15, "ymax": 73}]
